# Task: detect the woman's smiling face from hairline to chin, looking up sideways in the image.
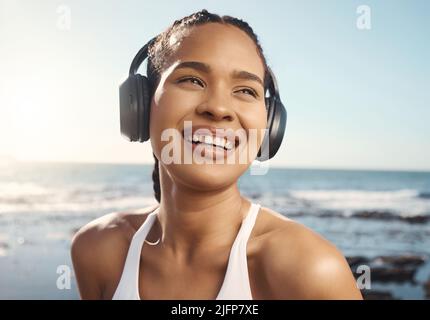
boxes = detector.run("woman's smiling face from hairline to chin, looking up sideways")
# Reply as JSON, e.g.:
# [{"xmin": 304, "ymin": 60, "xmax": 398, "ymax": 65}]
[{"xmin": 150, "ymin": 23, "xmax": 267, "ymax": 190}]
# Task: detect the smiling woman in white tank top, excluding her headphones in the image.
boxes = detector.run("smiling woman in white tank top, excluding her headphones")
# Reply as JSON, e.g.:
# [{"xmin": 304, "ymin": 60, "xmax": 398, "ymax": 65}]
[{"xmin": 71, "ymin": 10, "xmax": 361, "ymax": 299}]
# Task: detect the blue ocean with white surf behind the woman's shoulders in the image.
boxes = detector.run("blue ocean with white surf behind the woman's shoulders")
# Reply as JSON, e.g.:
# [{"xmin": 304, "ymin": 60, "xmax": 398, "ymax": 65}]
[{"xmin": 0, "ymin": 163, "xmax": 430, "ymax": 299}]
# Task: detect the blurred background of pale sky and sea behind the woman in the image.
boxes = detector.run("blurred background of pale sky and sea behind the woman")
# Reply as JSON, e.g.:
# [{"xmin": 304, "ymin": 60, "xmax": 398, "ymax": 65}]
[{"xmin": 0, "ymin": 0, "xmax": 430, "ymax": 299}]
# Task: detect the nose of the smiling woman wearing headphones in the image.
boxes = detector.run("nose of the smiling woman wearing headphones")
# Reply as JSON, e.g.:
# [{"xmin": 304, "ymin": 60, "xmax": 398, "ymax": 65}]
[{"xmin": 196, "ymin": 90, "xmax": 235, "ymax": 121}]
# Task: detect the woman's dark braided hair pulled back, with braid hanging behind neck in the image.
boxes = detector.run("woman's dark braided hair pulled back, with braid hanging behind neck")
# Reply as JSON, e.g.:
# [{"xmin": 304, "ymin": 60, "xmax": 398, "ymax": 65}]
[{"xmin": 146, "ymin": 9, "xmax": 269, "ymax": 202}]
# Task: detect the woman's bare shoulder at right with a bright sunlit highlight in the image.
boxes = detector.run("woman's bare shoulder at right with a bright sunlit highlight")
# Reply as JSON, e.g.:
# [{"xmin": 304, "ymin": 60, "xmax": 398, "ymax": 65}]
[{"xmin": 252, "ymin": 207, "xmax": 361, "ymax": 299}]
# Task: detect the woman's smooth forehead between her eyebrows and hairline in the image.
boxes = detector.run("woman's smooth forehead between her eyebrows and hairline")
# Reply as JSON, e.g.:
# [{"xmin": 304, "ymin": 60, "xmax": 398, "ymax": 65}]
[{"xmin": 169, "ymin": 23, "xmax": 265, "ymax": 77}]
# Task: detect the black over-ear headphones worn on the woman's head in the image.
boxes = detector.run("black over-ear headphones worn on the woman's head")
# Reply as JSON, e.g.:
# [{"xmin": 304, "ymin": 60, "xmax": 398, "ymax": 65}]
[{"xmin": 119, "ymin": 37, "xmax": 287, "ymax": 161}]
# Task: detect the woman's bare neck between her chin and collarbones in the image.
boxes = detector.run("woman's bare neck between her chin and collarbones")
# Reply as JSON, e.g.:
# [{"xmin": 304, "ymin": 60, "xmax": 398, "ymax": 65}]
[{"xmin": 158, "ymin": 166, "xmax": 250, "ymax": 259}]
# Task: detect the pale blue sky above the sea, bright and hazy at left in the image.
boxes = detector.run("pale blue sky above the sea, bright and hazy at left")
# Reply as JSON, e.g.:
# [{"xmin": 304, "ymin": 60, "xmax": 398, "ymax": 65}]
[{"xmin": 0, "ymin": 0, "xmax": 430, "ymax": 170}]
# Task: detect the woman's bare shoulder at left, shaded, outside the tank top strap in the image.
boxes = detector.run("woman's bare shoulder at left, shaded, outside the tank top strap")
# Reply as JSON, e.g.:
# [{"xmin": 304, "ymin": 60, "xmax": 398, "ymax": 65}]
[{"xmin": 71, "ymin": 206, "xmax": 155, "ymax": 299}]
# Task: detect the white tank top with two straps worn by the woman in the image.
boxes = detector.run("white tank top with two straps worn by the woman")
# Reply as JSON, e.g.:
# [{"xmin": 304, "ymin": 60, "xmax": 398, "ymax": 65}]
[{"xmin": 112, "ymin": 203, "xmax": 260, "ymax": 300}]
